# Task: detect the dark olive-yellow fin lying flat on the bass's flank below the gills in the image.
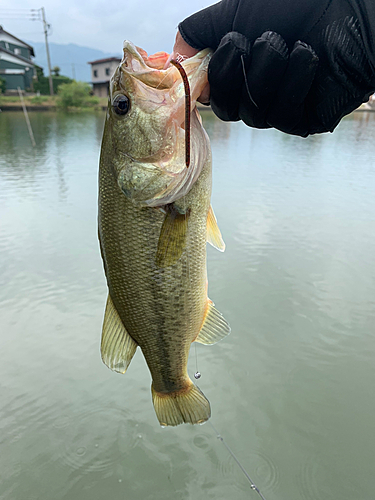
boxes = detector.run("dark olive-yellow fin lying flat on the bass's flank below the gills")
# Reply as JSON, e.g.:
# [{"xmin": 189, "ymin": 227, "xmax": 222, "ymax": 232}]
[{"xmin": 155, "ymin": 204, "xmax": 190, "ymax": 267}]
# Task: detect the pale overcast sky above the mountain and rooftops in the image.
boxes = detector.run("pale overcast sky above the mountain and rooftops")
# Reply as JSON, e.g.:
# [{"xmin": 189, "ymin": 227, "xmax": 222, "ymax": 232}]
[{"xmin": 0, "ymin": 0, "xmax": 215, "ymax": 54}]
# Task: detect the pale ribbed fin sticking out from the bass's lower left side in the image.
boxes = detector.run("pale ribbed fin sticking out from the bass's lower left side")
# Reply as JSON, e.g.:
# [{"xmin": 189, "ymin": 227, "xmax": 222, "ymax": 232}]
[{"xmin": 101, "ymin": 295, "xmax": 138, "ymax": 373}]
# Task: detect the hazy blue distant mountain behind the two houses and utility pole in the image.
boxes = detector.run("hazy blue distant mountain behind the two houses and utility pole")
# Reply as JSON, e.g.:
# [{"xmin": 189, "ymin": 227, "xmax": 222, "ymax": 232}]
[{"xmin": 25, "ymin": 40, "xmax": 121, "ymax": 82}]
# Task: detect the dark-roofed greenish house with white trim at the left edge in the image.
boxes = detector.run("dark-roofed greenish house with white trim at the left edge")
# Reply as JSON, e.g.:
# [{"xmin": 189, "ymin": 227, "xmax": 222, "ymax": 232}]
[{"xmin": 0, "ymin": 26, "xmax": 36, "ymax": 91}]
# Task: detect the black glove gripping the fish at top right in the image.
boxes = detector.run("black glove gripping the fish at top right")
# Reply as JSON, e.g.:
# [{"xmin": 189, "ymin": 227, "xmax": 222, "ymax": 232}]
[{"xmin": 179, "ymin": 0, "xmax": 375, "ymax": 137}]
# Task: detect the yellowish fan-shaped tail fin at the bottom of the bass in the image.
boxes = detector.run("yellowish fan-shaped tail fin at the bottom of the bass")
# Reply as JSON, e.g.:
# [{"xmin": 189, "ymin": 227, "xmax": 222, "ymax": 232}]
[{"xmin": 151, "ymin": 381, "xmax": 211, "ymax": 426}]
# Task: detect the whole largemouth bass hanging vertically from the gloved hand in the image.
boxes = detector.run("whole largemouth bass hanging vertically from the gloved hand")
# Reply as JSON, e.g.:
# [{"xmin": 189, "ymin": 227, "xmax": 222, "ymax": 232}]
[{"xmin": 98, "ymin": 41, "xmax": 230, "ymax": 426}]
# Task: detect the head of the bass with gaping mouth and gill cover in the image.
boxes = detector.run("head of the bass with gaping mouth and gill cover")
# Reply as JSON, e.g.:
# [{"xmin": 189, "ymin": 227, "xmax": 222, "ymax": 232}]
[{"xmin": 108, "ymin": 41, "xmax": 211, "ymax": 206}]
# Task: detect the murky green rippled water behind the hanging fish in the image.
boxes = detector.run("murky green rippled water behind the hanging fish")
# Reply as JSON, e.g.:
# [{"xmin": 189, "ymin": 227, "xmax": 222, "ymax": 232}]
[{"xmin": 0, "ymin": 113, "xmax": 375, "ymax": 500}]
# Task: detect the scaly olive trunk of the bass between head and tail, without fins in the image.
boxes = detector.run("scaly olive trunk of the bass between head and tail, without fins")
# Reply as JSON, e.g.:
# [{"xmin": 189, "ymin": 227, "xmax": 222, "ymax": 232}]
[{"xmin": 99, "ymin": 154, "xmax": 211, "ymax": 394}]
